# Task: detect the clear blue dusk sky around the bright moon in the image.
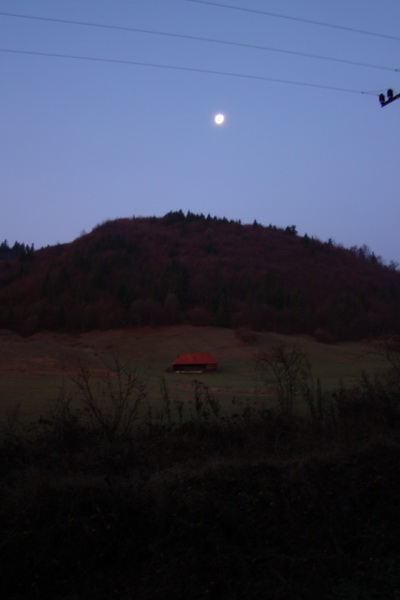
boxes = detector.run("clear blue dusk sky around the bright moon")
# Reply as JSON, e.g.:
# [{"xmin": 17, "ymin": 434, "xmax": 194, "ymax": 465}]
[{"xmin": 0, "ymin": 0, "xmax": 400, "ymax": 262}]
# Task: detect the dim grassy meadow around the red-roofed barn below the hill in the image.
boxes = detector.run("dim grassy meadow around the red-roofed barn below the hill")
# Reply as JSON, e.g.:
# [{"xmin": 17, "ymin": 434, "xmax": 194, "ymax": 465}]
[{"xmin": 0, "ymin": 326, "xmax": 385, "ymax": 419}]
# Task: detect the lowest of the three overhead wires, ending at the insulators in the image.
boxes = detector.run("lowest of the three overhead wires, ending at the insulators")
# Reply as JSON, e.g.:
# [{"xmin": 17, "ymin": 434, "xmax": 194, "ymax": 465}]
[{"xmin": 0, "ymin": 48, "xmax": 375, "ymax": 95}]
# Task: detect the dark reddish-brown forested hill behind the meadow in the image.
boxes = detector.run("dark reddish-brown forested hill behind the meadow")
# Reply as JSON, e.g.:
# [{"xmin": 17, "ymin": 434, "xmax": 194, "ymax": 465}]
[{"xmin": 0, "ymin": 211, "xmax": 400, "ymax": 341}]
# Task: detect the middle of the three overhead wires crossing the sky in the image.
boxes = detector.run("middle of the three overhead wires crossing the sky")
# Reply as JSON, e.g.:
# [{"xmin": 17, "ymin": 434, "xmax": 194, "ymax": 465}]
[{"xmin": 0, "ymin": 11, "xmax": 400, "ymax": 73}]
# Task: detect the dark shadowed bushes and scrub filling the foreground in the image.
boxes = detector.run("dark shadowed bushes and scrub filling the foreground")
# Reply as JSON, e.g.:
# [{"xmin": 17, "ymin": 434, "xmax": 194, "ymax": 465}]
[{"xmin": 0, "ymin": 346, "xmax": 400, "ymax": 600}]
